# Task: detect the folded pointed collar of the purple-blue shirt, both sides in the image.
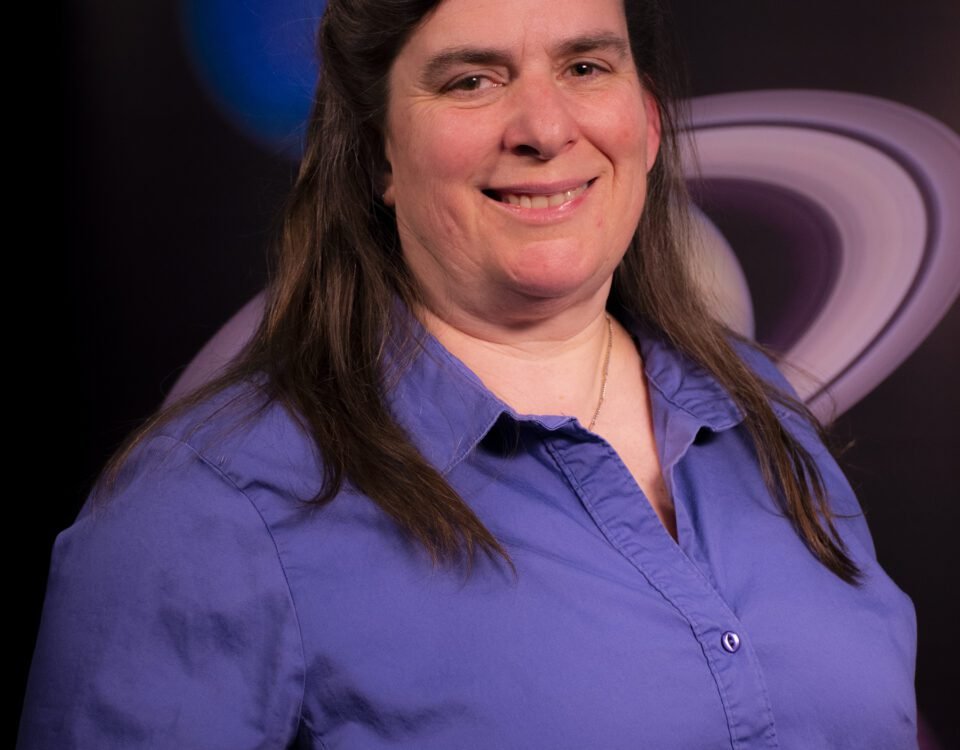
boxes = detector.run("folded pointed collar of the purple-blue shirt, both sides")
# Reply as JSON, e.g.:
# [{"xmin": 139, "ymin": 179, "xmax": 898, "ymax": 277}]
[{"xmin": 388, "ymin": 312, "xmax": 743, "ymax": 474}]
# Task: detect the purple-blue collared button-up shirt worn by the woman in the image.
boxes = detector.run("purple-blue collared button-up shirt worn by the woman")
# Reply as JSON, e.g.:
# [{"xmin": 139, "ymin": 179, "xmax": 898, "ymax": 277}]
[{"xmin": 19, "ymin": 320, "xmax": 917, "ymax": 750}]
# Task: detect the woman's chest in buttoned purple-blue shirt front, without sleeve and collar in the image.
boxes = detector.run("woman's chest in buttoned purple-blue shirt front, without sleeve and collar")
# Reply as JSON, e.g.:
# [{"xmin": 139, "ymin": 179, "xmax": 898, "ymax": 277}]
[{"xmin": 268, "ymin": 426, "xmax": 915, "ymax": 748}]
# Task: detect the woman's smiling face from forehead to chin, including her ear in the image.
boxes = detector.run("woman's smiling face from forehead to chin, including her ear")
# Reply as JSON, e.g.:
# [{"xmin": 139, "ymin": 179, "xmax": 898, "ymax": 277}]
[{"xmin": 384, "ymin": 0, "xmax": 660, "ymax": 324}]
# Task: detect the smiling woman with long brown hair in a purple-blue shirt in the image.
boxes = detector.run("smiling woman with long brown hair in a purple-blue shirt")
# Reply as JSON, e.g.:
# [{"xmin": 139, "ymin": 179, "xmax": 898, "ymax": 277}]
[{"xmin": 20, "ymin": 0, "xmax": 916, "ymax": 748}]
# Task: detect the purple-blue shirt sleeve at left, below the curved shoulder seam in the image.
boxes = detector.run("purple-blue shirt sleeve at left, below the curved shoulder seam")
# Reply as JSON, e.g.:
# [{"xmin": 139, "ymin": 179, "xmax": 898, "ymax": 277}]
[{"xmin": 18, "ymin": 436, "xmax": 304, "ymax": 750}]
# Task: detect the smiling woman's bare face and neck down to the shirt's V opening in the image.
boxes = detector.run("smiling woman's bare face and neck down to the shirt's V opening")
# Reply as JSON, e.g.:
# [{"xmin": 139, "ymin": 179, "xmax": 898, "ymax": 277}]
[{"xmin": 383, "ymin": 0, "xmax": 676, "ymax": 535}]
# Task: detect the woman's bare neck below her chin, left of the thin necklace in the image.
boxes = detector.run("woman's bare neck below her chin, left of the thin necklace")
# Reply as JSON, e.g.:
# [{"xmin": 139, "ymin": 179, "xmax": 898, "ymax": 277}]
[{"xmin": 419, "ymin": 289, "xmax": 616, "ymax": 426}]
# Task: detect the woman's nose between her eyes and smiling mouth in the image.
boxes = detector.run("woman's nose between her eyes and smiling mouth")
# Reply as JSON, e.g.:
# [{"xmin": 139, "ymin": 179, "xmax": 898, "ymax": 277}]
[{"xmin": 503, "ymin": 75, "xmax": 578, "ymax": 161}]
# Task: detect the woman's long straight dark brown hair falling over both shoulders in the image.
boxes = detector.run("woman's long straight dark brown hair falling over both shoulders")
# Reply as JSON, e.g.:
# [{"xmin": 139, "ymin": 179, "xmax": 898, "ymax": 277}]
[{"xmin": 101, "ymin": 0, "xmax": 859, "ymax": 583}]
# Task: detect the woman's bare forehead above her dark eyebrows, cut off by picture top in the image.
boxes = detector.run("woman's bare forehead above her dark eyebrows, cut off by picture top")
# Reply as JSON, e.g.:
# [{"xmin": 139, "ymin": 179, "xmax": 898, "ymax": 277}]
[{"xmin": 397, "ymin": 0, "xmax": 629, "ymax": 64}]
